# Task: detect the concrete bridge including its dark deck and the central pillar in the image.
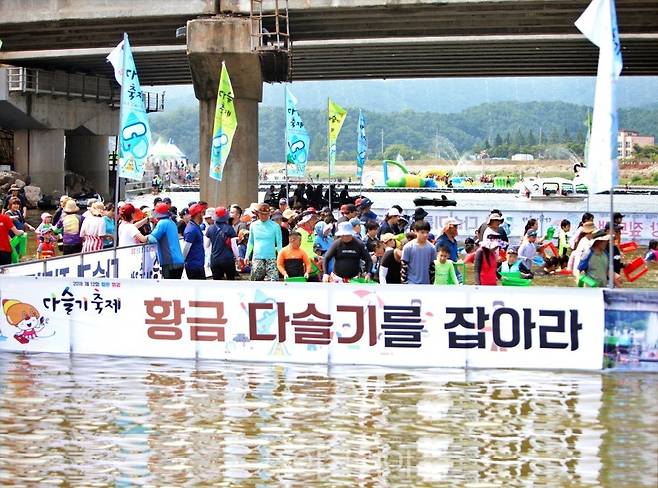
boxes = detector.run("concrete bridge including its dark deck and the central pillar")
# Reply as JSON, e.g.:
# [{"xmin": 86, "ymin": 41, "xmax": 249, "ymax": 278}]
[{"xmin": 0, "ymin": 0, "xmax": 658, "ymax": 203}]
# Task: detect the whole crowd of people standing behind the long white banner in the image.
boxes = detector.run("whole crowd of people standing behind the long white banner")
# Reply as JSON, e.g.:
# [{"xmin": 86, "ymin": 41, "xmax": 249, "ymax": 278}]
[{"xmin": 0, "ymin": 181, "xmax": 658, "ymax": 286}]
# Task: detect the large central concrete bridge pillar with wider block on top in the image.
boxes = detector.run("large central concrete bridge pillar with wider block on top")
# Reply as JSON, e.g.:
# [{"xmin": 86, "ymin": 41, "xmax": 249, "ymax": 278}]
[{"xmin": 187, "ymin": 17, "xmax": 263, "ymax": 208}]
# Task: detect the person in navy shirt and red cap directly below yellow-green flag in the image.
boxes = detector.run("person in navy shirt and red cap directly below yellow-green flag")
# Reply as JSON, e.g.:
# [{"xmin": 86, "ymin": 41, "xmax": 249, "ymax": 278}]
[{"xmin": 206, "ymin": 207, "xmax": 237, "ymax": 280}]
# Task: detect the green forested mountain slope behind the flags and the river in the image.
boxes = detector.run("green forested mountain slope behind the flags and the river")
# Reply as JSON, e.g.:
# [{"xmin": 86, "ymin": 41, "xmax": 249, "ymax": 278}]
[{"xmin": 151, "ymin": 101, "xmax": 658, "ymax": 161}]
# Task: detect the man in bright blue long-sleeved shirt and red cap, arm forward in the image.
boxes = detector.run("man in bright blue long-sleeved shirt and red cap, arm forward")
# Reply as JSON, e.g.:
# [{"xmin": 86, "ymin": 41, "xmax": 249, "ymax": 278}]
[{"xmin": 148, "ymin": 203, "xmax": 185, "ymax": 280}]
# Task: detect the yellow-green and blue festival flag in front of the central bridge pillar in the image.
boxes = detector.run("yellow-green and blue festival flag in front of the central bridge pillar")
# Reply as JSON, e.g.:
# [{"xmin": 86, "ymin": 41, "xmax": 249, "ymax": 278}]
[{"xmin": 210, "ymin": 61, "xmax": 238, "ymax": 181}]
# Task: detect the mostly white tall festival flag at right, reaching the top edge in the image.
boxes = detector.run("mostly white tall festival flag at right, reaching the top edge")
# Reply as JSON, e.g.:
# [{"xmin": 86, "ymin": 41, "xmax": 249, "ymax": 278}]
[{"xmin": 576, "ymin": 0, "xmax": 622, "ymax": 193}]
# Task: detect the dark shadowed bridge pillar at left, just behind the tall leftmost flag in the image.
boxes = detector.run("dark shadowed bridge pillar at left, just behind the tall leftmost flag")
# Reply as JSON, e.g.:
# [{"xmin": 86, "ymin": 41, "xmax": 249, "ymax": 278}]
[{"xmin": 66, "ymin": 134, "xmax": 110, "ymax": 199}]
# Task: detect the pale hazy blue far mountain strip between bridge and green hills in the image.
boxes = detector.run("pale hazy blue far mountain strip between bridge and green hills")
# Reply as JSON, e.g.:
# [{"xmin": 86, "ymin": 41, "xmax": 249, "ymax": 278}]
[{"xmin": 158, "ymin": 77, "xmax": 658, "ymax": 113}]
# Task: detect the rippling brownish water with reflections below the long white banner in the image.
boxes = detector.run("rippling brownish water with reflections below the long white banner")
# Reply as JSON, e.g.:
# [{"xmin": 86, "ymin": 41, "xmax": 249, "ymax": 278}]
[{"xmin": 0, "ymin": 353, "xmax": 658, "ymax": 486}]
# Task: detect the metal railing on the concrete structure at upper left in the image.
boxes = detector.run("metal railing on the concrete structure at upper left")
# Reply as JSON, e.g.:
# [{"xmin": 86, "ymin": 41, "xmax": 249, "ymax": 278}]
[{"xmin": 7, "ymin": 67, "xmax": 165, "ymax": 112}]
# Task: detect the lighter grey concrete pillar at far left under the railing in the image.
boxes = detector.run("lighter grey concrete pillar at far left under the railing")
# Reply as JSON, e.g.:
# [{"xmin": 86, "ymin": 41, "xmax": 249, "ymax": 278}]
[{"xmin": 14, "ymin": 129, "xmax": 65, "ymax": 195}]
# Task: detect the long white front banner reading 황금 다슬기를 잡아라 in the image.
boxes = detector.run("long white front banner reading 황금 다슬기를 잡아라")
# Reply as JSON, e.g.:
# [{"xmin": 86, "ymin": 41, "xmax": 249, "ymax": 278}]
[{"xmin": 0, "ymin": 278, "xmax": 604, "ymax": 370}]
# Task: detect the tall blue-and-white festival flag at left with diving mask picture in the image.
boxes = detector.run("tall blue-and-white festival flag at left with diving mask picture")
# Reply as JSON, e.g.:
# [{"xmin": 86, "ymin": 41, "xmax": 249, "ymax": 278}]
[{"xmin": 107, "ymin": 33, "xmax": 151, "ymax": 180}]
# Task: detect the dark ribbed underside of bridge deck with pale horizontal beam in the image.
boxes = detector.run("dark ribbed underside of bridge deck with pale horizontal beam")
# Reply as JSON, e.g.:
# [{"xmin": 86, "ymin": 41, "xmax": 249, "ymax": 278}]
[{"xmin": 0, "ymin": 0, "xmax": 658, "ymax": 85}]
